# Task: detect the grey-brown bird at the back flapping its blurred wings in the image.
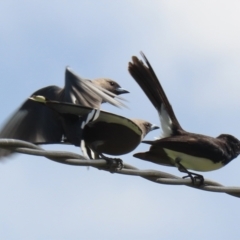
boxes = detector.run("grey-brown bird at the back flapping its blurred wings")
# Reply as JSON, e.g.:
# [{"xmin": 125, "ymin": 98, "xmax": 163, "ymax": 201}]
[{"xmin": 0, "ymin": 67, "xmax": 129, "ymax": 158}]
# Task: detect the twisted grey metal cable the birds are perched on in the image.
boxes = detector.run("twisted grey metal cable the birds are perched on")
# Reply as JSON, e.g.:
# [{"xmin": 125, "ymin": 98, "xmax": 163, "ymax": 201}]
[{"xmin": 0, "ymin": 139, "xmax": 240, "ymax": 198}]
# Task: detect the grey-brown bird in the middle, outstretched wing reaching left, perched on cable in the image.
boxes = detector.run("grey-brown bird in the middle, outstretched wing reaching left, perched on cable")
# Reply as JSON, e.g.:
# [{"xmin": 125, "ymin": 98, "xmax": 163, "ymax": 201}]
[{"xmin": 28, "ymin": 96, "xmax": 159, "ymax": 163}]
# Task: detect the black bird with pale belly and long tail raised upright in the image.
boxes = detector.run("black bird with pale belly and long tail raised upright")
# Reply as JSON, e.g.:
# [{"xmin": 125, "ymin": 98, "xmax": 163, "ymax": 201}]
[{"xmin": 128, "ymin": 52, "xmax": 240, "ymax": 185}]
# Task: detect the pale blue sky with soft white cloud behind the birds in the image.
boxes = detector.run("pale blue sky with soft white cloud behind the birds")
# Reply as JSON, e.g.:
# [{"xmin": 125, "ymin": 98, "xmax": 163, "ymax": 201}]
[{"xmin": 0, "ymin": 0, "xmax": 240, "ymax": 240}]
